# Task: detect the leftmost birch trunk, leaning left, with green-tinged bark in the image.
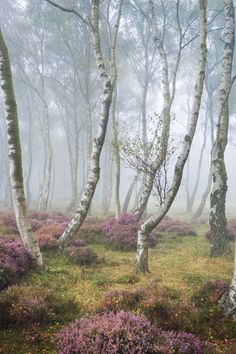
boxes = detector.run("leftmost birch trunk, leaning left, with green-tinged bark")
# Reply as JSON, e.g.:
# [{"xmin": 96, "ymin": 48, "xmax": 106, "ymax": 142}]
[{"xmin": 0, "ymin": 30, "xmax": 43, "ymax": 266}]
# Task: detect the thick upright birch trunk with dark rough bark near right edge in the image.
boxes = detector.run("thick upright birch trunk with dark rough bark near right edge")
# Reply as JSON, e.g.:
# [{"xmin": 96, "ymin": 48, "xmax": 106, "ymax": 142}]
[{"xmin": 209, "ymin": 0, "xmax": 235, "ymax": 257}]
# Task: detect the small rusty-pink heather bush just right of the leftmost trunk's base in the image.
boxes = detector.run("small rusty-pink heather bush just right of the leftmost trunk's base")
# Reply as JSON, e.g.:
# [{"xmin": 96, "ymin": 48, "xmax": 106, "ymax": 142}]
[{"xmin": 35, "ymin": 224, "xmax": 64, "ymax": 250}]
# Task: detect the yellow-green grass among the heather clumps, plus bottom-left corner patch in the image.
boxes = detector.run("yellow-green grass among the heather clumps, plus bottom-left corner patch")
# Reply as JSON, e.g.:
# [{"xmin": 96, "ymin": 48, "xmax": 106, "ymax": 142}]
[{"xmin": 0, "ymin": 227, "xmax": 233, "ymax": 354}]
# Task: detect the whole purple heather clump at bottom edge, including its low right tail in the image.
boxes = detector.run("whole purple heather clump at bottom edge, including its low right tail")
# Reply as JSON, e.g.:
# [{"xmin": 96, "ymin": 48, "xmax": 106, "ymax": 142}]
[{"xmin": 57, "ymin": 311, "xmax": 204, "ymax": 354}]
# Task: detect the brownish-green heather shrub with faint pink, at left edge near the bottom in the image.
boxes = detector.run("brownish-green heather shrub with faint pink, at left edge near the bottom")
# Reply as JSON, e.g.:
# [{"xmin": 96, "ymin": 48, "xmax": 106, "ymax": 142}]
[{"xmin": 0, "ymin": 285, "xmax": 78, "ymax": 327}]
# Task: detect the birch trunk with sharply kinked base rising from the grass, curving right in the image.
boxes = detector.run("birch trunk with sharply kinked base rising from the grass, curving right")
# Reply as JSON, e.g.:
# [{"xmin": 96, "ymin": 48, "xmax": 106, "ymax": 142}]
[{"xmin": 136, "ymin": 0, "xmax": 207, "ymax": 272}]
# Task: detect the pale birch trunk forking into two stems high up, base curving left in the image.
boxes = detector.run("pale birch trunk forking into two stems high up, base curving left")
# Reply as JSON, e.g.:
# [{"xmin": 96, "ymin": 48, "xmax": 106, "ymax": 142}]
[{"xmin": 59, "ymin": 0, "xmax": 123, "ymax": 246}]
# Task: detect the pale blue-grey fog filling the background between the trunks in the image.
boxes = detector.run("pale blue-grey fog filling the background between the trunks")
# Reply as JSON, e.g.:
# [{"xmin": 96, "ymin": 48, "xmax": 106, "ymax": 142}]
[{"xmin": 0, "ymin": 0, "xmax": 236, "ymax": 218}]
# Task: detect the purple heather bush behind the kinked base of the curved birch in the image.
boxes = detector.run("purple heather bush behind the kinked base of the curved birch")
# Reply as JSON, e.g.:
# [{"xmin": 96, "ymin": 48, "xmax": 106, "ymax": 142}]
[{"xmin": 101, "ymin": 214, "xmax": 156, "ymax": 251}]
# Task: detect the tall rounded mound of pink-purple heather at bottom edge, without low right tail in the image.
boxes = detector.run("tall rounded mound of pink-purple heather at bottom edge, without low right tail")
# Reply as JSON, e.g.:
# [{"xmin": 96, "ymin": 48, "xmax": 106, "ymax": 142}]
[{"xmin": 57, "ymin": 311, "xmax": 158, "ymax": 354}]
